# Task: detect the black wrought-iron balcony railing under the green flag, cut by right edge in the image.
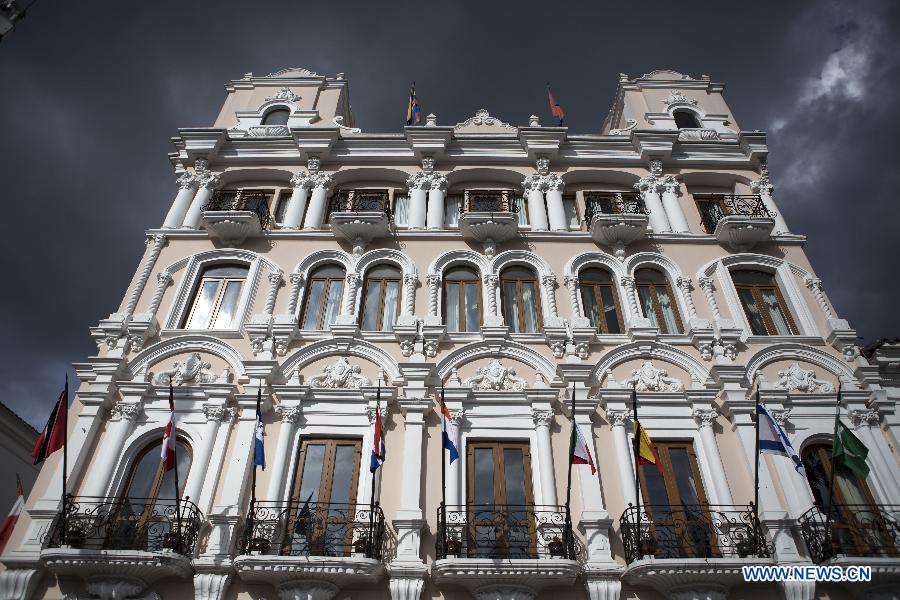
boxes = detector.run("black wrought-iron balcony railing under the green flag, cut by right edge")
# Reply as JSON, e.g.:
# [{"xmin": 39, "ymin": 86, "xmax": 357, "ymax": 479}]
[{"xmin": 798, "ymin": 504, "xmax": 900, "ymax": 563}]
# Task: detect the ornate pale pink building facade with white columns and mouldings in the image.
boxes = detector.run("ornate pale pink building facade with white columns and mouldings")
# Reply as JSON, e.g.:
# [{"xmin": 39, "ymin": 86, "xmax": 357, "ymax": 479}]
[{"xmin": 0, "ymin": 69, "xmax": 900, "ymax": 600}]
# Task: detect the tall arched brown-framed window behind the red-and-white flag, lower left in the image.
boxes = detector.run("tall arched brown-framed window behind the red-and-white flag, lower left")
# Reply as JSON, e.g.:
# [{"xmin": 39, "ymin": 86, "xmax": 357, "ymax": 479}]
[{"xmin": 114, "ymin": 438, "xmax": 194, "ymax": 551}]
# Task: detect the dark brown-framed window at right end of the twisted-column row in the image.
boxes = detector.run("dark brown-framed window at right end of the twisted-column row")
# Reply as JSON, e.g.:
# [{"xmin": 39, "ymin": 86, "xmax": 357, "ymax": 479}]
[{"xmin": 731, "ymin": 269, "xmax": 797, "ymax": 335}]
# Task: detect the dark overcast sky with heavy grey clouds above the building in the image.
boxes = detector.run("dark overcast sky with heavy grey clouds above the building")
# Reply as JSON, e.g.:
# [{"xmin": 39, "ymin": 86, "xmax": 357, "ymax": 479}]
[{"xmin": 0, "ymin": 0, "xmax": 900, "ymax": 427}]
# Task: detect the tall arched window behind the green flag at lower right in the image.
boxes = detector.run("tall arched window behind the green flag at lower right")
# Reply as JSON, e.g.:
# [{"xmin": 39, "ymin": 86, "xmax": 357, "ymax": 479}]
[{"xmin": 803, "ymin": 444, "xmax": 880, "ymax": 556}]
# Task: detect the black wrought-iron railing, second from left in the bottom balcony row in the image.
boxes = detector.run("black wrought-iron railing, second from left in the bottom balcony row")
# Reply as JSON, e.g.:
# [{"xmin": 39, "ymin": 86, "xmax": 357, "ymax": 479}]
[{"xmin": 241, "ymin": 500, "xmax": 384, "ymax": 560}]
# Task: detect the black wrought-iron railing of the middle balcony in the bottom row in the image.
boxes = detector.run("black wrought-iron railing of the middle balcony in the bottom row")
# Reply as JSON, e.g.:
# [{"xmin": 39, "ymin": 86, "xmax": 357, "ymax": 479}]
[{"xmin": 436, "ymin": 504, "xmax": 576, "ymax": 560}]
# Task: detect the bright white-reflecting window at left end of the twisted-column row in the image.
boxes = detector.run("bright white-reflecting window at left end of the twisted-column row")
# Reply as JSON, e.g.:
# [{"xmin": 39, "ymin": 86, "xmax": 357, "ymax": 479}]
[{"xmin": 183, "ymin": 264, "xmax": 247, "ymax": 329}]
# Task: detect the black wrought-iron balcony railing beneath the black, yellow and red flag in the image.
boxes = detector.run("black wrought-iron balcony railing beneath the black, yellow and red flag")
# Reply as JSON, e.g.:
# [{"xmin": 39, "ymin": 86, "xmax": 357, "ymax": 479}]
[{"xmin": 619, "ymin": 503, "xmax": 771, "ymax": 563}]
